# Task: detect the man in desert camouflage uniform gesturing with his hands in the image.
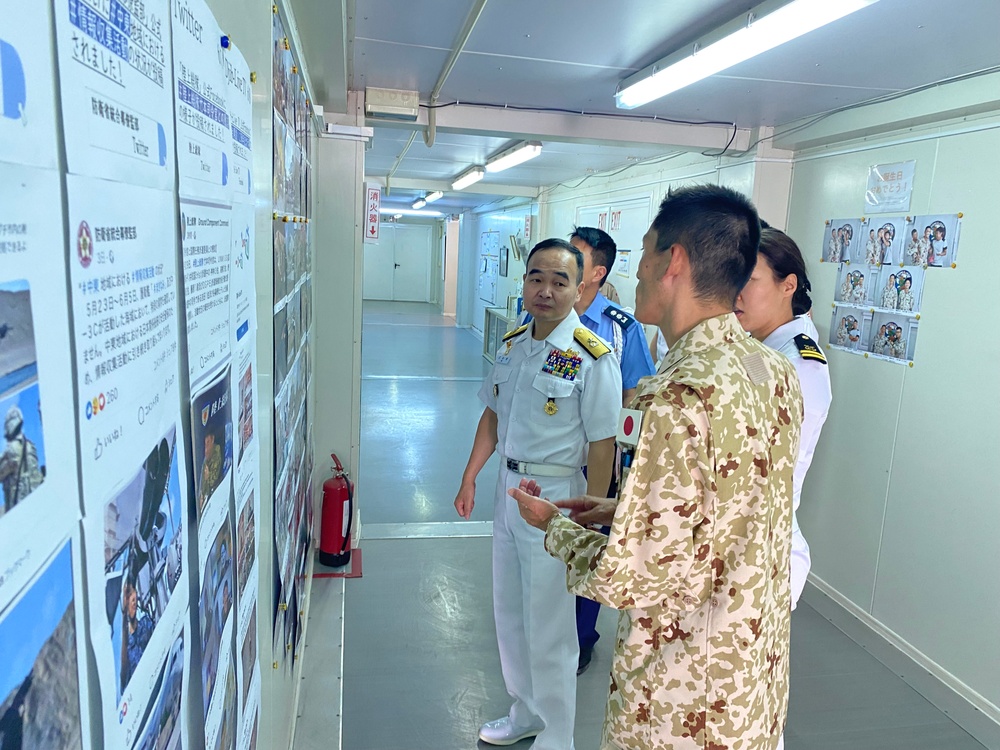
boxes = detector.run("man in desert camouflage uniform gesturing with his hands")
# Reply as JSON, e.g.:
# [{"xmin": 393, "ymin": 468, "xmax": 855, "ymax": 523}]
[{"xmin": 510, "ymin": 186, "xmax": 803, "ymax": 750}]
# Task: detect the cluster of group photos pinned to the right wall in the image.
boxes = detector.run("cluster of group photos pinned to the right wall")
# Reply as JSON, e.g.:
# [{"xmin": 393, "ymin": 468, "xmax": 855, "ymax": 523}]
[{"xmin": 821, "ymin": 214, "xmax": 962, "ymax": 366}]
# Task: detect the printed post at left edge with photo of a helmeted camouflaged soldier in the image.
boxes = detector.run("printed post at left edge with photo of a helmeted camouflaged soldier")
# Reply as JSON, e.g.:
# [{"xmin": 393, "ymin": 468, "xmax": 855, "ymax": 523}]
[{"xmin": 0, "ymin": 165, "xmax": 80, "ymax": 604}]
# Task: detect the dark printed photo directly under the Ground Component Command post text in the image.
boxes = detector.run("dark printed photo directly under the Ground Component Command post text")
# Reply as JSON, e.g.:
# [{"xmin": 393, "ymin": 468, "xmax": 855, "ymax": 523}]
[{"xmin": 191, "ymin": 367, "xmax": 233, "ymax": 521}]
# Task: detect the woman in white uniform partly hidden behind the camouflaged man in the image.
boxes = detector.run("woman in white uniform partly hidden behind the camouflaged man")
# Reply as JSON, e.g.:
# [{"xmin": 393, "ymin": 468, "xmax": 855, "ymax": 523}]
[{"xmin": 735, "ymin": 228, "xmax": 833, "ymax": 747}]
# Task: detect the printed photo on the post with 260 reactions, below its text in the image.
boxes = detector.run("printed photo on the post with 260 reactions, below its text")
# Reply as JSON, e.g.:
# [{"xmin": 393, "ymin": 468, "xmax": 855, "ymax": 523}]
[{"xmin": 104, "ymin": 428, "xmax": 184, "ymax": 699}]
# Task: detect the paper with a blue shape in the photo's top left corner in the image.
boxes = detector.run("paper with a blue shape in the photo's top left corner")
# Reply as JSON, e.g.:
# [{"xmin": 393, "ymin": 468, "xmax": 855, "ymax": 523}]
[{"xmin": 0, "ymin": 0, "xmax": 57, "ymax": 169}]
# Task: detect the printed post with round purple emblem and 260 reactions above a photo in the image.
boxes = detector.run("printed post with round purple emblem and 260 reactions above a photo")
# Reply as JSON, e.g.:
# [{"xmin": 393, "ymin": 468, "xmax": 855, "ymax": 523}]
[{"xmin": 67, "ymin": 175, "xmax": 188, "ymax": 747}]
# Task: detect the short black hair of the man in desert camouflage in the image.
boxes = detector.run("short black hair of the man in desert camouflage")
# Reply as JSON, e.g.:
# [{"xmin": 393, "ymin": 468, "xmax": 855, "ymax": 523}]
[{"xmin": 652, "ymin": 185, "xmax": 760, "ymax": 307}]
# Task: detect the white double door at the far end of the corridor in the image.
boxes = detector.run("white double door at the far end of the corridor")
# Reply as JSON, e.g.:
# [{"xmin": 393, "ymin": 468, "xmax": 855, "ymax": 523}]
[{"xmin": 364, "ymin": 224, "xmax": 434, "ymax": 302}]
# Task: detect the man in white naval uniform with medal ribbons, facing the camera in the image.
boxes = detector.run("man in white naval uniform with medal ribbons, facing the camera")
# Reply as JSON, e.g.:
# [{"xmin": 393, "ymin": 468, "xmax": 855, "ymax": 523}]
[{"xmin": 455, "ymin": 239, "xmax": 622, "ymax": 750}]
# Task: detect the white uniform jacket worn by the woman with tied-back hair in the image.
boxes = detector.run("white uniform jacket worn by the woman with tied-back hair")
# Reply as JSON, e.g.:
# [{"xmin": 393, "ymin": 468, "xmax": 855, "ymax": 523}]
[{"xmin": 763, "ymin": 315, "xmax": 833, "ymax": 609}]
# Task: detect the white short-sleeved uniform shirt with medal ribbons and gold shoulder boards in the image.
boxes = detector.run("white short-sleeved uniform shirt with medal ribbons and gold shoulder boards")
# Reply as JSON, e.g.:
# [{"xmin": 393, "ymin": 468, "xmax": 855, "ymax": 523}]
[{"xmin": 479, "ymin": 310, "xmax": 622, "ymax": 470}]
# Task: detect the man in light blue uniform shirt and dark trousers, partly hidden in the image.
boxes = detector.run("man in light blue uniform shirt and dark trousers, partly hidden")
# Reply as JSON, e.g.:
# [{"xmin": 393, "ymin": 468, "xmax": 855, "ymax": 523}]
[{"xmin": 569, "ymin": 227, "xmax": 656, "ymax": 674}]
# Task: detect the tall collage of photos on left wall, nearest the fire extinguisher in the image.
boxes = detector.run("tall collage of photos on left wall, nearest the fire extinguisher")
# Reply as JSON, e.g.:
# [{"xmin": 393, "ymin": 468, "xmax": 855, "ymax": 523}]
[{"xmin": 272, "ymin": 5, "xmax": 313, "ymax": 668}]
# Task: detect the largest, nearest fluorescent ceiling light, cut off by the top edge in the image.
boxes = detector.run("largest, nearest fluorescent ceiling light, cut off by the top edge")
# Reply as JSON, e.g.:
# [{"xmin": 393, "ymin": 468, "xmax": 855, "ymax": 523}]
[{"xmin": 612, "ymin": 0, "xmax": 878, "ymax": 108}]
